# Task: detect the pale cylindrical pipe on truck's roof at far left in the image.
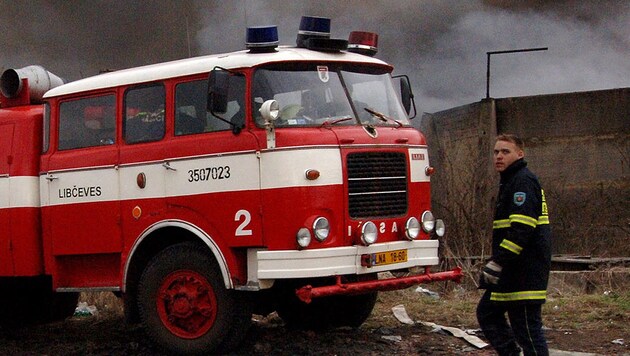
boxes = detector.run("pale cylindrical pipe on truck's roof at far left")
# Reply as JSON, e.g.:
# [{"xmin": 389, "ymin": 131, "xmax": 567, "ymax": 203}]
[{"xmin": 0, "ymin": 65, "xmax": 65, "ymax": 103}]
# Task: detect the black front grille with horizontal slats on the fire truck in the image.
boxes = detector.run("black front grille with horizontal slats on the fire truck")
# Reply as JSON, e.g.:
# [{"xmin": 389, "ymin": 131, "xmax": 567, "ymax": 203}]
[{"xmin": 346, "ymin": 152, "xmax": 407, "ymax": 218}]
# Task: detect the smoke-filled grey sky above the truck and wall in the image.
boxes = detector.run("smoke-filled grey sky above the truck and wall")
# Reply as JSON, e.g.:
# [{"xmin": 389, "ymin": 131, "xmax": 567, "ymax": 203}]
[{"xmin": 0, "ymin": 0, "xmax": 630, "ymax": 112}]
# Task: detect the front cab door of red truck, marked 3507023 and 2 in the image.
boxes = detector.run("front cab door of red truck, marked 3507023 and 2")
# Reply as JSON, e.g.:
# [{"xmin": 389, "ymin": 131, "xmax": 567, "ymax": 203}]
[{"xmin": 164, "ymin": 73, "xmax": 262, "ymax": 246}]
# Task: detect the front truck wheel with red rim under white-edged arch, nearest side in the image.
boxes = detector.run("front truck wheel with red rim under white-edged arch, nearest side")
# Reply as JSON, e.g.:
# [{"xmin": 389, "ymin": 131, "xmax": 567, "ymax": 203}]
[{"xmin": 138, "ymin": 243, "xmax": 251, "ymax": 354}]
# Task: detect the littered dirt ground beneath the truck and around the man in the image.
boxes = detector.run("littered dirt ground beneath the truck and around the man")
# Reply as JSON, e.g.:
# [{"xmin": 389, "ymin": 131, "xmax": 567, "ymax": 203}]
[{"xmin": 0, "ymin": 286, "xmax": 630, "ymax": 355}]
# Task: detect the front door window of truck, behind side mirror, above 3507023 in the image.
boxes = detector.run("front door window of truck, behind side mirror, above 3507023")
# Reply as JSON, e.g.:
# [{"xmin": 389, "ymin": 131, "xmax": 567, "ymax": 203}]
[{"xmin": 175, "ymin": 76, "xmax": 245, "ymax": 136}]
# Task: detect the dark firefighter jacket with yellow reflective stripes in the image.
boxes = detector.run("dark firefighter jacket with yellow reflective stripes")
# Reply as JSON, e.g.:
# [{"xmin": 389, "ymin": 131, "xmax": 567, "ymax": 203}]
[{"xmin": 482, "ymin": 159, "xmax": 551, "ymax": 303}]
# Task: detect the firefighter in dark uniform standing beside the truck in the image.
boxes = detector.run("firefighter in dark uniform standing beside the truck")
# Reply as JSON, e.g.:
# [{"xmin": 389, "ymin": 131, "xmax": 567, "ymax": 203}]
[{"xmin": 477, "ymin": 134, "xmax": 551, "ymax": 356}]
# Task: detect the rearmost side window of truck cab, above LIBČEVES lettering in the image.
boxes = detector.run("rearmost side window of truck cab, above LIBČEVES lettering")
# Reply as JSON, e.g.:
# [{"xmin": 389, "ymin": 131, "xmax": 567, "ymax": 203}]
[{"xmin": 58, "ymin": 94, "xmax": 116, "ymax": 150}]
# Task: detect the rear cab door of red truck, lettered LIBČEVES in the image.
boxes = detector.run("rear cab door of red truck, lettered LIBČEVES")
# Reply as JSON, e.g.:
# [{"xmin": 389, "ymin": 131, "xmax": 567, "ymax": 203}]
[{"xmin": 44, "ymin": 93, "xmax": 122, "ymax": 260}]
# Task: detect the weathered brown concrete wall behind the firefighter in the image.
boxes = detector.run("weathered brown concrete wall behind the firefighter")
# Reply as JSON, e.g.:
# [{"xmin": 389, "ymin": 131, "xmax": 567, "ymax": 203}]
[{"xmin": 420, "ymin": 88, "xmax": 630, "ymax": 256}]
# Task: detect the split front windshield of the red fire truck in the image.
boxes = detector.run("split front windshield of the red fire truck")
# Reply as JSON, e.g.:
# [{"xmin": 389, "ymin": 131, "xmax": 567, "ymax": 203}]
[{"xmin": 252, "ymin": 63, "xmax": 409, "ymax": 127}]
